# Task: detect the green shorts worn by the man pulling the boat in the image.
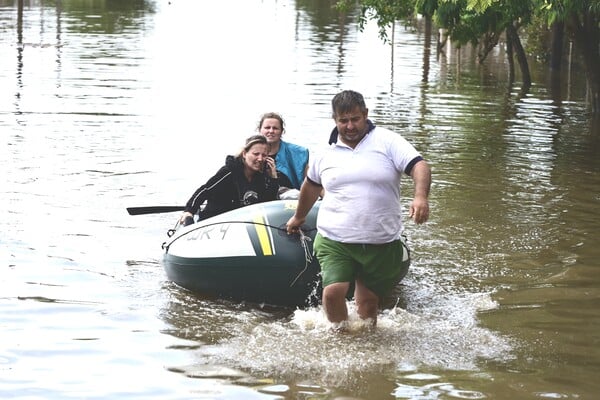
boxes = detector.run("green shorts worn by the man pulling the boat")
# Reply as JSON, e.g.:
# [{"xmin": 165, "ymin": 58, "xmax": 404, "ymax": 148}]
[{"xmin": 313, "ymin": 233, "xmax": 410, "ymax": 297}]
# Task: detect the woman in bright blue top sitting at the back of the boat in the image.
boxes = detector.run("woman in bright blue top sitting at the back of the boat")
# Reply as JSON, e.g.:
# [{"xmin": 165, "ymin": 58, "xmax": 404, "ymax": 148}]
[{"xmin": 258, "ymin": 112, "xmax": 308, "ymax": 193}]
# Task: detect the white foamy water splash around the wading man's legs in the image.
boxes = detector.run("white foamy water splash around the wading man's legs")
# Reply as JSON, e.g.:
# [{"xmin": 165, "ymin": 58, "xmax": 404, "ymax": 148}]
[{"xmin": 201, "ymin": 294, "xmax": 512, "ymax": 385}]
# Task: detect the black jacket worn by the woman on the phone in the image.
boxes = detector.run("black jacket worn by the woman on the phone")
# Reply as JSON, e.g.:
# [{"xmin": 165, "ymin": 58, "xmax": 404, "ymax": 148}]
[{"xmin": 185, "ymin": 156, "xmax": 291, "ymax": 220}]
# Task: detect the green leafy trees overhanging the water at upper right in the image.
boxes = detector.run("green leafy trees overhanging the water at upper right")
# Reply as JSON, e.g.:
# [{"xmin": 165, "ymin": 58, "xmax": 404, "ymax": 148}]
[{"xmin": 337, "ymin": 0, "xmax": 600, "ymax": 114}]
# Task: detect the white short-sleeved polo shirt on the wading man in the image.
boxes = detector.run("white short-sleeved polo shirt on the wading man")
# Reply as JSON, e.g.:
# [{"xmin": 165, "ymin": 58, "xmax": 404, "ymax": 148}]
[{"xmin": 307, "ymin": 127, "xmax": 420, "ymax": 244}]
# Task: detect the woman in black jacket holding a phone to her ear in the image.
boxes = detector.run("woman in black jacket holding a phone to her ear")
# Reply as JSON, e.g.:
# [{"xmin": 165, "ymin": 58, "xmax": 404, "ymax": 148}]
[{"xmin": 180, "ymin": 135, "xmax": 291, "ymax": 225}]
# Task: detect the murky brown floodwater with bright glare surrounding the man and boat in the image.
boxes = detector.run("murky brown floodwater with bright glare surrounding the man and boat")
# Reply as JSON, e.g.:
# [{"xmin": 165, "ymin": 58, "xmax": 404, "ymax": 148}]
[{"xmin": 0, "ymin": 0, "xmax": 600, "ymax": 399}]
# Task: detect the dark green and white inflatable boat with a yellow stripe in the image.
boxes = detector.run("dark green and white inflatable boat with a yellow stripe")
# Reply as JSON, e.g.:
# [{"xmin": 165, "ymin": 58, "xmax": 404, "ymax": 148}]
[{"xmin": 158, "ymin": 200, "xmax": 320, "ymax": 307}]
